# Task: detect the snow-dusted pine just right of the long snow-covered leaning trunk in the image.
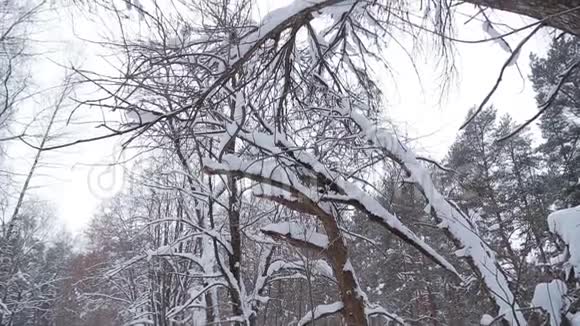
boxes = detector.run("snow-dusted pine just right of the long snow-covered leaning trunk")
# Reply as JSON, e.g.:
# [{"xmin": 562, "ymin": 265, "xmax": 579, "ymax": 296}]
[{"xmin": 446, "ymin": 108, "xmax": 553, "ymax": 308}]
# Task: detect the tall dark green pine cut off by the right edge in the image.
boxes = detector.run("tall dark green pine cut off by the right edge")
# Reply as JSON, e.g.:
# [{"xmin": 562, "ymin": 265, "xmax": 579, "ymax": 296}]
[{"xmin": 530, "ymin": 37, "xmax": 580, "ymax": 208}]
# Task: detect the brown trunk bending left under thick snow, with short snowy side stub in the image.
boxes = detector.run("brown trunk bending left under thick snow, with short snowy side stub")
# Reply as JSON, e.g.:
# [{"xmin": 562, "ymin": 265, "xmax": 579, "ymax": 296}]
[{"xmin": 204, "ymin": 149, "xmax": 376, "ymax": 325}]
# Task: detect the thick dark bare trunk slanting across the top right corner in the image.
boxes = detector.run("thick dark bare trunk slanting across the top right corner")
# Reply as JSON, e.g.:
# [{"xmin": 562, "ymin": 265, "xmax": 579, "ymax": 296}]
[{"xmin": 465, "ymin": 0, "xmax": 580, "ymax": 36}]
